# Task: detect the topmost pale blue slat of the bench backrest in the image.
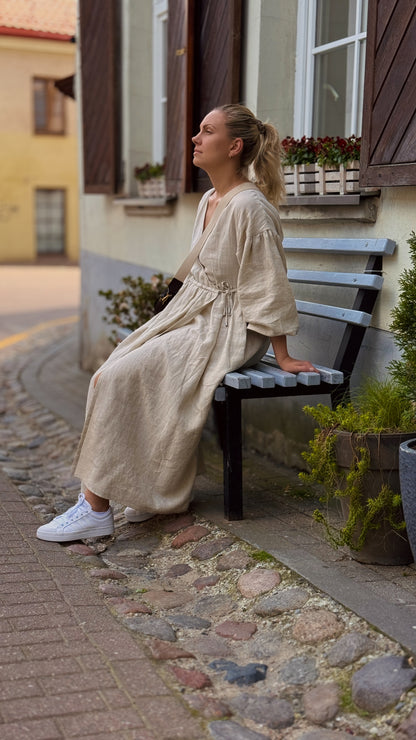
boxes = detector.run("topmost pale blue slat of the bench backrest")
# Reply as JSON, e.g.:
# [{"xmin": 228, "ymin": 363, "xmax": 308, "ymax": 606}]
[{"xmin": 283, "ymin": 241, "xmax": 396, "ymax": 255}]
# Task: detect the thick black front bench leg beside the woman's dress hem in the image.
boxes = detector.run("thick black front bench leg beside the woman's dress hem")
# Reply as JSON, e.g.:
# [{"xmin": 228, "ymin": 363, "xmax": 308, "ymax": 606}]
[{"xmin": 223, "ymin": 392, "xmax": 243, "ymax": 521}]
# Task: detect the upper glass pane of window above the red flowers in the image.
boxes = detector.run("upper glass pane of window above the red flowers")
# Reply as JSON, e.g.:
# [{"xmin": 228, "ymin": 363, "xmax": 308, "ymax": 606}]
[{"xmin": 316, "ymin": 0, "xmax": 357, "ymax": 46}]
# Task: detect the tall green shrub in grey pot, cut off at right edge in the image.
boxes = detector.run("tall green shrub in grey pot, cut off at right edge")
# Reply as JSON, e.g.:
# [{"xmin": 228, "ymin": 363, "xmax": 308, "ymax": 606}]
[{"xmin": 389, "ymin": 232, "xmax": 416, "ymax": 560}]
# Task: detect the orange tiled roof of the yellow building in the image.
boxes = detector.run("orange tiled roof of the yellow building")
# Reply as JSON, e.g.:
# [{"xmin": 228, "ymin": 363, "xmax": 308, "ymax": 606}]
[{"xmin": 0, "ymin": 0, "xmax": 77, "ymax": 36}]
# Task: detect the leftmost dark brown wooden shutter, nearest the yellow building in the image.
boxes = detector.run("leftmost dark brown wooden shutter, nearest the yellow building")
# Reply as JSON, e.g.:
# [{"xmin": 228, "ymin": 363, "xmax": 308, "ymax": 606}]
[{"xmin": 80, "ymin": 0, "xmax": 121, "ymax": 194}]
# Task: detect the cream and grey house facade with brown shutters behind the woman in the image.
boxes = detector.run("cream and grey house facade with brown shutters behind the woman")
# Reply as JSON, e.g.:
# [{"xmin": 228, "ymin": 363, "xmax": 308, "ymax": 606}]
[{"xmin": 78, "ymin": 0, "xmax": 416, "ymax": 465}]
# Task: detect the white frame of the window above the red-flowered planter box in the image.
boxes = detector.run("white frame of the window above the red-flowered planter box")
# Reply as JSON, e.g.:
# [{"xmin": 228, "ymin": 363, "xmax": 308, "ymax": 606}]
[{"xmin": 293, "ymin": 0, "xmax": 367, "ymax": 139}]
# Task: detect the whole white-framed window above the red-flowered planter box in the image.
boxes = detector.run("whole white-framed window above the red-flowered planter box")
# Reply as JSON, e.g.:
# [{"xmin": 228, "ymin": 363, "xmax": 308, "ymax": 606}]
[{"xmin": 294, "ymin": 0, "xmax": 368, "ymax": 137}]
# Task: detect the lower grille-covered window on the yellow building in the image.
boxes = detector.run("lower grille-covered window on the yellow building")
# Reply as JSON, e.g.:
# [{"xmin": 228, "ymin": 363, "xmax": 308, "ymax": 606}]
[{"xmin": 35, "ymin": 188, "xmax": 65, "ymax": 255}]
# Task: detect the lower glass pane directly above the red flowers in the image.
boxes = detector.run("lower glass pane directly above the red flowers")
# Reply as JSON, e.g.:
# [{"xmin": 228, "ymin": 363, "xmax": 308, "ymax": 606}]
[{"xmin": 312, "ymin": 44, "xmax": 354, "ymax": 136}]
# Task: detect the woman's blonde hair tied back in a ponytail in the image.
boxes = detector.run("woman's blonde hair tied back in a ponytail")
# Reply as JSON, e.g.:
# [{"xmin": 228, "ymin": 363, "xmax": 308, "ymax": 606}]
[{"xmin": 216, "ymin": 103, "xmax": 286, "ymax": 205}]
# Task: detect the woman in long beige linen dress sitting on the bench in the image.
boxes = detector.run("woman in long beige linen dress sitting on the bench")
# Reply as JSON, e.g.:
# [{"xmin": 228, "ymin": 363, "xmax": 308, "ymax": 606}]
[{"xmin": 37, "ymin": 105, "xmax": 314, "ymax": 542}]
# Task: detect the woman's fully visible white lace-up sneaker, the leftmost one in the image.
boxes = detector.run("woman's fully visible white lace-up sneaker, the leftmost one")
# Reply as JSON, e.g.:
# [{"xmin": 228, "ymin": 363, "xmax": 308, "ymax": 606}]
[{"xmin": 36, "ymin": 493, "xmax": 114, "ymax": 542}]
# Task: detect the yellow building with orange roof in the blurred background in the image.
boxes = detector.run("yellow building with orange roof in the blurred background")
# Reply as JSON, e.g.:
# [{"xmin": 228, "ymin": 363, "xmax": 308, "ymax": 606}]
[{"xmin": 0, "ymin": 0, "xmax": 79, "ymax": 263}]
